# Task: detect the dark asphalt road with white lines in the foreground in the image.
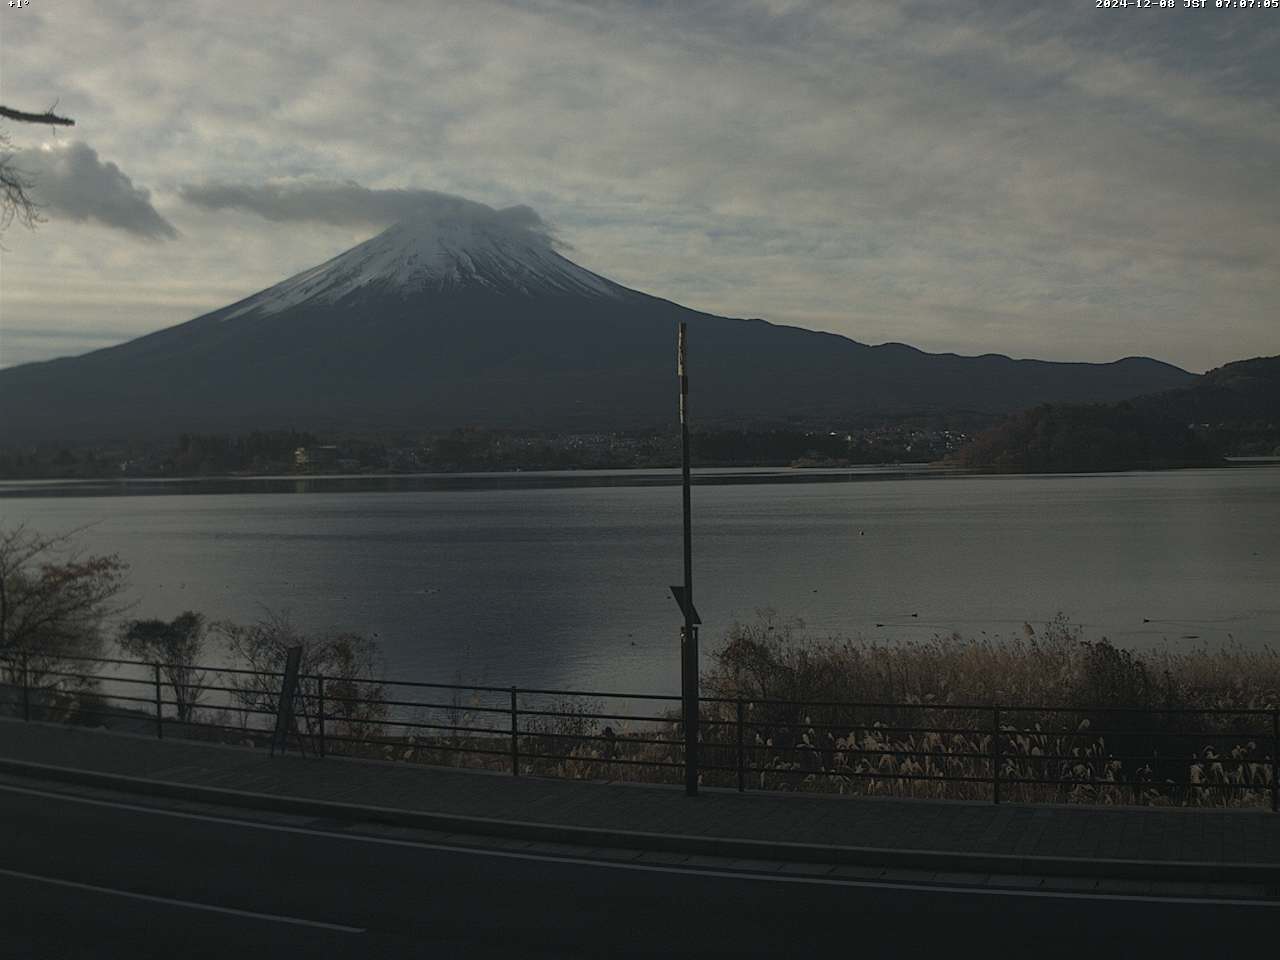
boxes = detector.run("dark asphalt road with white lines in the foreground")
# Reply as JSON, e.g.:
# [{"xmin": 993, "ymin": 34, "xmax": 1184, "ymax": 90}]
[{"xmin": 0, "ymin": 783, "xmax": 1280, "ymax": 960}]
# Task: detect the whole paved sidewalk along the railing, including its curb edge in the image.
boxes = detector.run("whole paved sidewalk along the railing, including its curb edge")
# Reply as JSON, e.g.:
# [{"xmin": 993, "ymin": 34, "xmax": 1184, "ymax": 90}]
[{"xmin": 0, "ymin": 721, "xmax": 1280, "ymax": 884}]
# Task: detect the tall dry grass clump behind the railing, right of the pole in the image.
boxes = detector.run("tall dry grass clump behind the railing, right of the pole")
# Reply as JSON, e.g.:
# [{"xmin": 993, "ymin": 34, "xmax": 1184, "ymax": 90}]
[{"xmin": 703, "ymin": 609, "xmax": 1280, "ymax": 804}]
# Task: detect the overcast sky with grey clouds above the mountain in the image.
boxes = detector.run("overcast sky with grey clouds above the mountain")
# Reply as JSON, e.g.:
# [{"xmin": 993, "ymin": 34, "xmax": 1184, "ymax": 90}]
[{"xmin": 0, "ymin": 0, "xmax": 1280, "ymax": 371}]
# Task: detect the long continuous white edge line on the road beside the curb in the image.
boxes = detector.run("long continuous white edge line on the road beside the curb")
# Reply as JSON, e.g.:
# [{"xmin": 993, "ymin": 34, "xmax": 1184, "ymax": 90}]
[{"xmin": 0, "ymin": 782, "xmax": 1280, "ymax": 909}]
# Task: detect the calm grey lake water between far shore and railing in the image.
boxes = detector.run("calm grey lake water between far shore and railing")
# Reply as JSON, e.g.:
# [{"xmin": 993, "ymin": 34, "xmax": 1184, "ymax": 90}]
[{"xmin": 0, "ymin": 466, "xmax": 1280, "ymax": 692}]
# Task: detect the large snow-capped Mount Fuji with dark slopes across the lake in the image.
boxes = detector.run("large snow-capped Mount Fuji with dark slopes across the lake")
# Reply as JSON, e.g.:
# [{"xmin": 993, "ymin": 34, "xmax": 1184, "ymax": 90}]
[{"xmin": 0, "ymin": 204, "xmax": 1196, "ymax": 444}]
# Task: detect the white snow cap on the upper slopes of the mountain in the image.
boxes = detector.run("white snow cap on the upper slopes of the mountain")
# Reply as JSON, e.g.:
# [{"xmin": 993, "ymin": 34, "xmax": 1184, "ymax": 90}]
[{"xmin": 223, "ymin": 205, "xmax": 635, "ymax": 320}]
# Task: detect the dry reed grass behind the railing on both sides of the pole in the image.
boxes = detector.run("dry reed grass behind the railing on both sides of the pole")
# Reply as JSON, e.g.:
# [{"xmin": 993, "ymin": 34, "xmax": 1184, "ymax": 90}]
[{"xmin": 82, "ymin": 611, "xmax": 1280, "ymax": 806}]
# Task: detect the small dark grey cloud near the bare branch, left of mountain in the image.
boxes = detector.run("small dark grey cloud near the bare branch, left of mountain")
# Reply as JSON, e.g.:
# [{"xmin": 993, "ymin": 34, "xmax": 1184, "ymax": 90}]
[{"xmin": 14, "ymin": 141, "xmax": 178, "ymax": 239}]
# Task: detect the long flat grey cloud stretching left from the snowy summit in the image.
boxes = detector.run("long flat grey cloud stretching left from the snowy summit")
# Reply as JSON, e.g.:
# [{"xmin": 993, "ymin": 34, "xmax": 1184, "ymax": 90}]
[{"xmin": 180, "ymin": 180, "xmax": 554, "ymax": 244}]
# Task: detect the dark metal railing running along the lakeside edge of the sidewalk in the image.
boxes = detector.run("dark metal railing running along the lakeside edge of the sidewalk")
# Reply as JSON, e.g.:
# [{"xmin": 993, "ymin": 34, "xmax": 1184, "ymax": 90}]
[{"xmin": 0, "ymin": 657, "xmax": 1280, "ymax": 812}]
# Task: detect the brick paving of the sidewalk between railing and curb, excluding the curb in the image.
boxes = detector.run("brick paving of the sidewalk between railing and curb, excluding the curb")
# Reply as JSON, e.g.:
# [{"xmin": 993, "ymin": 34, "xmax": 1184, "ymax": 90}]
[{"xmin": 0, "ymin": 721, "xmax": 1280, "ymax": 865}]
